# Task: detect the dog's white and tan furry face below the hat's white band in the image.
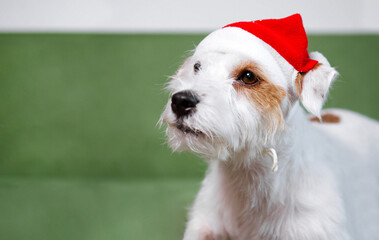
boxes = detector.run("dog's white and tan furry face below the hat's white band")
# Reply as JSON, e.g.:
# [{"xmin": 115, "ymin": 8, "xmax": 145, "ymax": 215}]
[{"xmin": 161, "ymin": 51, "xmax": 287, "ymax": 159}]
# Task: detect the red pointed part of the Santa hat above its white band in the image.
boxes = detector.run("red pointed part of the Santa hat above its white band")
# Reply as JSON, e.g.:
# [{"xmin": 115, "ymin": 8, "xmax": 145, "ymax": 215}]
[{"xmin": 224, "ymin": 14, "xmax": 317, "ymax": 72}]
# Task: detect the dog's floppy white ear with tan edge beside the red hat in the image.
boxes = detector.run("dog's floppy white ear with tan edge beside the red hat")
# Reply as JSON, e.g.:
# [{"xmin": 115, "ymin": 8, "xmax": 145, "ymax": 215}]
[{"xmin": 296, "ymin": 52, "xmax": 338, "ymax": 118}]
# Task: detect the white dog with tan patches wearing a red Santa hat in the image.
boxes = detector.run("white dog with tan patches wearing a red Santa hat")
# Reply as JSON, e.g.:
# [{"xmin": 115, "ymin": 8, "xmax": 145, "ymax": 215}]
[{"xmin": 161, "ymin": 14, "xmax": 379, "ymax": 240}]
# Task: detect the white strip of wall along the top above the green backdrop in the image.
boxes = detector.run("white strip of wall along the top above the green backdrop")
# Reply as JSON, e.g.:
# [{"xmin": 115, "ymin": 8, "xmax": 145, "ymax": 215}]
[{"xmin": 0, "ymin": 0, "xmax": 379, "ymax": 33}]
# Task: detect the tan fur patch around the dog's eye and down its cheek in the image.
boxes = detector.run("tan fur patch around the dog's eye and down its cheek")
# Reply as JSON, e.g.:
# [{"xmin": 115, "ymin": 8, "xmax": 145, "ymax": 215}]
[{"xmin": 231, "ymin": 61, "xmax": 287, "ymax": 131}]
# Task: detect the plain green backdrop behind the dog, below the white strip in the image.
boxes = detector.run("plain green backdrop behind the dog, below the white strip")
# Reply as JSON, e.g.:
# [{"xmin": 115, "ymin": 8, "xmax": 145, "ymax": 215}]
[{"xmin": 0, "ymin": 34, "xmax": 379, "ymax": 240}]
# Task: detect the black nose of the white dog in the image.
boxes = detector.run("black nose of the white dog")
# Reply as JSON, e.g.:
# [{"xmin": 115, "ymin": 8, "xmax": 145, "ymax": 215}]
[{"xmin": 171, "ymin": 90, "xmax": 199, "ymax": 118}]
